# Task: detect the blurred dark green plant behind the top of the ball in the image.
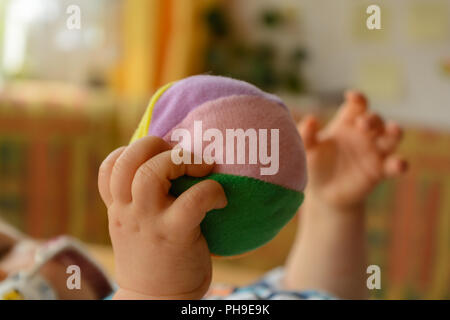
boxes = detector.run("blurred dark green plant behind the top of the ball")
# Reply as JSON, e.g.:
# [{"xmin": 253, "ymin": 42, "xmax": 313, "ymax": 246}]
[{"xmin": 205, "ymin": 7, "xmax": 307, "ymax": 93}]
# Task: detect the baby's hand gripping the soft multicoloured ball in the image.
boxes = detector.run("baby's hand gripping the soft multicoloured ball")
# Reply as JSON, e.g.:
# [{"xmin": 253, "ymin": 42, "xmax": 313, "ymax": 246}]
[{"xmin": 98, "ymin": 137, "xmax": 227, "ymax": 299}]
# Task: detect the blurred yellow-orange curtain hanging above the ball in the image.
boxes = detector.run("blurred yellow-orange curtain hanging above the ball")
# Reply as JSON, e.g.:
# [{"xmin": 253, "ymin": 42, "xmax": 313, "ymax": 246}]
[{"xmin": 116, "ymin": 0, "xmax": 215, "ymax": 99}]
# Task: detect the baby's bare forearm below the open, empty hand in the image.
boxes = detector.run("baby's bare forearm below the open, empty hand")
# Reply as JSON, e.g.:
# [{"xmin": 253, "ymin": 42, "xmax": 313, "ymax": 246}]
[{"xmin": 285, "ymin": 192, "xmax": 367, "ymax": 299}]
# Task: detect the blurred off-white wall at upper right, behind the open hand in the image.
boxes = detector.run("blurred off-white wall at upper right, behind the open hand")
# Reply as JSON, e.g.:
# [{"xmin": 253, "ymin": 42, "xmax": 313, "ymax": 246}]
[{"xmin": 229, "ymin": 0, "xmax": 450, "ymax": 130}]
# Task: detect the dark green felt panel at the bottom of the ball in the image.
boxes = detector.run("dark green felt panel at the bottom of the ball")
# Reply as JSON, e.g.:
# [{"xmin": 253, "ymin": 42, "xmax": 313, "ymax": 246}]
[{"xmin": 170, "ymin": 173, "xmax": 304, "ymax": 256}]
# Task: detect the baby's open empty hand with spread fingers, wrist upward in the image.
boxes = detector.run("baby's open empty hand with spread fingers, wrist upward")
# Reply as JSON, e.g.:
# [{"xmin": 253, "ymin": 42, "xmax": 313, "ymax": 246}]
[{"xmin": 299, "ymin": 92, "xmax": 407, "ymax": 209}]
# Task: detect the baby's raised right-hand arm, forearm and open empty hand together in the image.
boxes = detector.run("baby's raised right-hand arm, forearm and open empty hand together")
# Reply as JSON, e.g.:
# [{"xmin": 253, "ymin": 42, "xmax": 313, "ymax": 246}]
[{"xmin": 284, "ymin": 92, "xmax": 407, "ymax": 299}]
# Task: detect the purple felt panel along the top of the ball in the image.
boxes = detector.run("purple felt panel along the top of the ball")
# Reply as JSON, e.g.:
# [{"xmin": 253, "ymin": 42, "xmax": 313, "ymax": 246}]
[{"xmin": 148, "ymin": 75, "xmax": 285, "ymax": 138}]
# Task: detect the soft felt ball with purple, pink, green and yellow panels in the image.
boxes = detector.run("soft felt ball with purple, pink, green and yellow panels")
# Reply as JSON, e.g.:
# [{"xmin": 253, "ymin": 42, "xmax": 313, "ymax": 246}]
[{"xmin": 132, "ymin": 75, "xmax": 306, "ymax": 256}]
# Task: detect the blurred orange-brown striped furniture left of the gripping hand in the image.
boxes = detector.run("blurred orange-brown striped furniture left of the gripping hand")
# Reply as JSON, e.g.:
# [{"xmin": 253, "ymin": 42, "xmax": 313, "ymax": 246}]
[{"xmin": 0, "ymin": 82, "xmax": 117, "ymax": 242}]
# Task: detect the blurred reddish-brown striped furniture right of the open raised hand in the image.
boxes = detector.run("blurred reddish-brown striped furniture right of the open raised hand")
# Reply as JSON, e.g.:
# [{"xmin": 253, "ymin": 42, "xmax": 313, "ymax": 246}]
[{"xmin": 368, "ymin": 130, "xmax": 450, "ymax": 299}]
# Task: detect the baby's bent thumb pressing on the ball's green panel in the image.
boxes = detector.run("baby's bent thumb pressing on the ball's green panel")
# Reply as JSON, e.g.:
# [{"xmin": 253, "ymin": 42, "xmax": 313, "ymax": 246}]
[{"xmin": 165, "ymin": 180, "xmax": 227, "ymax": 236}]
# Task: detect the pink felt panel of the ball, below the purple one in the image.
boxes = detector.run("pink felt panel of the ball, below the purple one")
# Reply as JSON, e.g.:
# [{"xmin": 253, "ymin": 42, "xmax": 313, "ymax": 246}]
[{"xmin": 164, "ymin": 95, "xmax": 306, "ymax": 191}]
